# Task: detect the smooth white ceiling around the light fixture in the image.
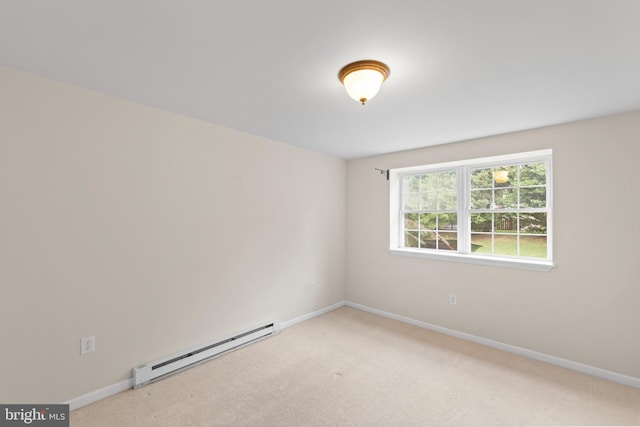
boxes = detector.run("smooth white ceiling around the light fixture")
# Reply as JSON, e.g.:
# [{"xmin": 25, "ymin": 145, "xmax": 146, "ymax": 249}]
[{"xmin": 0, "ymin": 0, "xmax": 640, "ymax": 158}]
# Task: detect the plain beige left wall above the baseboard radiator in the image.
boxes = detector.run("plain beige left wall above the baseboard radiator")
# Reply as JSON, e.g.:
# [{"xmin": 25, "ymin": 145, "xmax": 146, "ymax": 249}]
[{"xmin": 0, "ymin": 68, "xmax": 346, "ymax": 403}]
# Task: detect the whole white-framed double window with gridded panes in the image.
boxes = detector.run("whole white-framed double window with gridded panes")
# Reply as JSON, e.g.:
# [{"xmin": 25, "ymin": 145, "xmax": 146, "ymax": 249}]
[{"xmin": 389, "ymin": 150, "xmax": 553, "ymax": 270}]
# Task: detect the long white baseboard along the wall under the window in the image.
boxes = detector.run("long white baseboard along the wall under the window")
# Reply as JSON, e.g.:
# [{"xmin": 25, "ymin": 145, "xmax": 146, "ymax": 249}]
[{"xmin": 345, "ymin": 301, "xmax": 640, "ymax": 388}]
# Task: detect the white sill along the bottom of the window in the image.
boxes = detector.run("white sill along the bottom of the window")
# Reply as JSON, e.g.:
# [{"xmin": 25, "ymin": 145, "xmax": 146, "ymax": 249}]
[{"xmin": 389, "ymin": 248, "xmax": 555, "ymax": 271}]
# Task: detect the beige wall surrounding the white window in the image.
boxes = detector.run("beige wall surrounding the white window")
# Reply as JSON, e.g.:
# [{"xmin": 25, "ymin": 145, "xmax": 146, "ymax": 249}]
[{"xmin": 347, "ymin": 112, "xmax": 640, "ymax": 378}]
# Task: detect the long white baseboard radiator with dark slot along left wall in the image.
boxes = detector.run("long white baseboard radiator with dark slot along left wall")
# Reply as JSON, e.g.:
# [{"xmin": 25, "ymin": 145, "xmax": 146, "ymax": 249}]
[{"xmin": 133, "ymin": 322, "xmax": 280, "ymax": 388}]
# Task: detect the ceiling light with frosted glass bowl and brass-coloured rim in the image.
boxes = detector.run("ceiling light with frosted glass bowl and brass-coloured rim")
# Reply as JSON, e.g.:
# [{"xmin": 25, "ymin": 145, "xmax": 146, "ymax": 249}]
[{"xmin": 338, "ymin": 59, "xmax": 391, "ymax": 105}]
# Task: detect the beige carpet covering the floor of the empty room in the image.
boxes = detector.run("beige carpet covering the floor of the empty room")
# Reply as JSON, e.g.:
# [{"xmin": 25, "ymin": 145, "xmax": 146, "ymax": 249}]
[{"xmin": 71, "ymin": 307, "xmax": 640, "ymax": 427}]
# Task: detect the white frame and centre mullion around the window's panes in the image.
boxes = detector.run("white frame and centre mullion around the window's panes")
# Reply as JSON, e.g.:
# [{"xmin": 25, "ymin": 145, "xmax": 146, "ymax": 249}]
[{"xmin": 389, "ymin": 149, "xmax": 554, "ymax": 271}]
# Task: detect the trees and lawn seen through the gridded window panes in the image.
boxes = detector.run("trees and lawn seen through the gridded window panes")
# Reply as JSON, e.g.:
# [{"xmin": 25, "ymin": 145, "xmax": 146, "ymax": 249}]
[{"xmin": 400, "ymin": 160, "xmax": 549, "ymax": 258}]
